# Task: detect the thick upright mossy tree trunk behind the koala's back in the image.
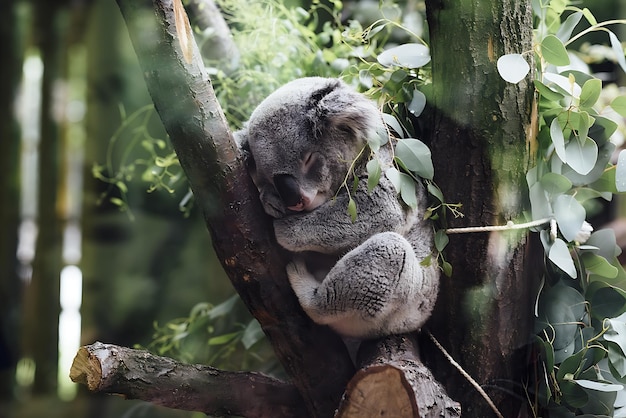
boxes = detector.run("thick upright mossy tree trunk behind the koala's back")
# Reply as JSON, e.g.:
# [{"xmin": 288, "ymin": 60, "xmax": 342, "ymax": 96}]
[{"xmin": 426, "ymin": 0, "xmax": 533, "ymax": 417}]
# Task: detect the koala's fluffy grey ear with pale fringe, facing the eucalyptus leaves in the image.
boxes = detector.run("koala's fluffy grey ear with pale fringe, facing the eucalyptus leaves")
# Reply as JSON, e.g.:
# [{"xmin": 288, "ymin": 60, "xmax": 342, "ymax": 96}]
[{"xmin": 308, "ymin": 80, "xmax": 381, "ymax": 140}]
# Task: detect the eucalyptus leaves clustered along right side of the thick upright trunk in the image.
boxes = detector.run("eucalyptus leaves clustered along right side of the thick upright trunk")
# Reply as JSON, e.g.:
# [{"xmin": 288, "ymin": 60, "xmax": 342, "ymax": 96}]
[{"xmin": 498, "ymin": 0, "xmax": 626, "ymax": 416}]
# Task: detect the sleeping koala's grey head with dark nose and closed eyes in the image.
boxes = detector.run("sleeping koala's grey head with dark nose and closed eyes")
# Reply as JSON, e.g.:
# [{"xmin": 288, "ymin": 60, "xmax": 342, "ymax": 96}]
[{"xmin": 235, "ymin": 77, "xmax": 382, "ymax": 218}]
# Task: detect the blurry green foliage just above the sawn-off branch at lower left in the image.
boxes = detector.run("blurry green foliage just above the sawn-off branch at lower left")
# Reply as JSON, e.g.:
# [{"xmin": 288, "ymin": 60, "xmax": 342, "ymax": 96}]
[{"xmin": 141, "ymin": 295, "xmax": 282, "ymax": 374}]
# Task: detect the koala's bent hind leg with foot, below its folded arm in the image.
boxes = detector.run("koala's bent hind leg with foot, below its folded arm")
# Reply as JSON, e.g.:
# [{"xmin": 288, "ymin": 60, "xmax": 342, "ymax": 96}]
[{"xmin": 287, "ymin": 232, "xmax": 438, "ymax": 338}]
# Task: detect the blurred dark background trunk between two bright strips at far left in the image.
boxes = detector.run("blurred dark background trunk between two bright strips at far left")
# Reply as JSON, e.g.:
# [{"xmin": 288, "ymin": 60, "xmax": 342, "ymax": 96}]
[{"xmin": 24, "ymin": 1, "xmax": 63, "ymax": 394}]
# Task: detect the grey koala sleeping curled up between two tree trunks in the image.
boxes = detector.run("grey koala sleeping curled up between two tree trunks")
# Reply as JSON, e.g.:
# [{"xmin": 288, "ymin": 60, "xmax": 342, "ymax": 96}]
[{"xmin": 235, "ymin": 77, "xmax": 439, "ymax": 339}]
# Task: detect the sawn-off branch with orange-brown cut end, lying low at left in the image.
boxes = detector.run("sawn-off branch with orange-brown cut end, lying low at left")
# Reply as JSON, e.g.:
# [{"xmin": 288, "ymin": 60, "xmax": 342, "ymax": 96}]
[{"xmin": 70, "ymin": 343, "xmax": 306, "ymax": 418}]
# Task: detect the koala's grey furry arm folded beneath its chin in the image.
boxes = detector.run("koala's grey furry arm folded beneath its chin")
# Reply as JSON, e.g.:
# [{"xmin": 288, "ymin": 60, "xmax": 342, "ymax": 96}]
[{"xmin": 274, "ymin": 177, "xmax": 411, "ymax": 254}]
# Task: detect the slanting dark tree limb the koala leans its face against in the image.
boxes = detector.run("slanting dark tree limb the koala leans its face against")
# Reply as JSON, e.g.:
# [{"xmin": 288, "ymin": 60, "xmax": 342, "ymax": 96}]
[{"xmin": 112, "ymin": 0, "xmax": 354, "ymax": 417}]
